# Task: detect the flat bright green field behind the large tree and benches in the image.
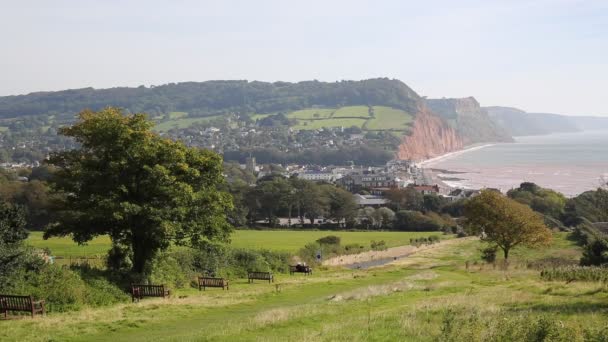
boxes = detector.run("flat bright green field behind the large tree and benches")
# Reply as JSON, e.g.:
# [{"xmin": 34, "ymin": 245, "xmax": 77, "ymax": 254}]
[{"xmin": 27, "ymin": 230, "xmax": 441, "ymax": 257}]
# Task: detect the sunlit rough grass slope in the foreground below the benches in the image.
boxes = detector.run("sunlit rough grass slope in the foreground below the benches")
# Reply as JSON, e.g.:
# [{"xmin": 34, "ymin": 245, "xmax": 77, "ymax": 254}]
[{"xmin": 9, "ymin": 234, "xmax": 608, "ymax": 342}]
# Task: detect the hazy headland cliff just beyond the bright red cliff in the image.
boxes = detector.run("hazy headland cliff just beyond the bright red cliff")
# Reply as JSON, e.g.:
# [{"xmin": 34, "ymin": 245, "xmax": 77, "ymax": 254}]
[{"xmin": 426, "ymin": 97, "xmax": 513, "ymax": 145}]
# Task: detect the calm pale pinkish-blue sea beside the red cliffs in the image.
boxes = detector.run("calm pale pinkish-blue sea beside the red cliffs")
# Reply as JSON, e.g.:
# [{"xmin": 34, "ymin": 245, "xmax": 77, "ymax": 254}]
[{"xmin": 420, "ymin": 131, "xmax": 608, "ymax": 197}]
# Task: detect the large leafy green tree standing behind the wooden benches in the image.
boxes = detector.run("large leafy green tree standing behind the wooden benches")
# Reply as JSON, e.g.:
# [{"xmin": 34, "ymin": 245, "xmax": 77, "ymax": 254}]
[{"xmin": 44, "ymin": 108, "xmax": 232, "ymax": 274}]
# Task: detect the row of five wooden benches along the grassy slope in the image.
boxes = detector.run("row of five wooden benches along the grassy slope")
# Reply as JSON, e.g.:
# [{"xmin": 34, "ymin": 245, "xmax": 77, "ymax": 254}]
[{"xmin": 0, "ymin": 265, "xmax": 312, "ymax": 318}]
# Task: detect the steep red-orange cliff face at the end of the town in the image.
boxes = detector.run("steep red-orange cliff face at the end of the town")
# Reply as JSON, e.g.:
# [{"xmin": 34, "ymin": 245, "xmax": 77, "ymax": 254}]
[{"xmin": 397, "ymin": 108, "xmax": 464, "ymax": 161}]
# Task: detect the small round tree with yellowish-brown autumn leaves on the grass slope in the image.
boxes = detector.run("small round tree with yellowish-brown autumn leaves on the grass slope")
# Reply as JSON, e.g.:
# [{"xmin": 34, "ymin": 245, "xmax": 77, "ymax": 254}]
[{"xmin": 465, "ymin": 190, "xmax": 551, "ymax": 260}]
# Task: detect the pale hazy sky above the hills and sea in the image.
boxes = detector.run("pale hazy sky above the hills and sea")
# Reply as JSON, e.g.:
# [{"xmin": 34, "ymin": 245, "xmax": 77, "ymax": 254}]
[{"xmin": 0, "ymin": 0, "xmax": 608, "ymax": 116}]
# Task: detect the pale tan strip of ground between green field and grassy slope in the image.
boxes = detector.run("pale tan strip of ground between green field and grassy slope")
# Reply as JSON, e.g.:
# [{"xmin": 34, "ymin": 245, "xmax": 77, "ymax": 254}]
[{"xmin": 322, "ymin": 239, "xmax": 470, "ymax": 266}]
